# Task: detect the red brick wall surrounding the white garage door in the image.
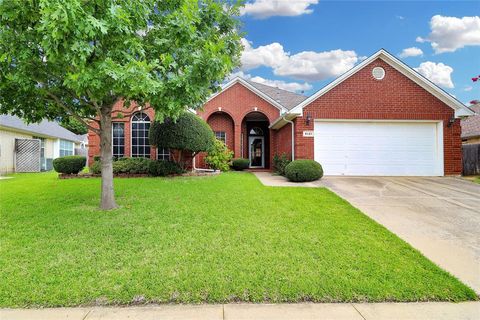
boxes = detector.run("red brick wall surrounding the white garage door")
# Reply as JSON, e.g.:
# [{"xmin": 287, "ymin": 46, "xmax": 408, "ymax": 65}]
[{"xmin": 295, "ymin": 59, "xmax": 462, "ymax": 175}]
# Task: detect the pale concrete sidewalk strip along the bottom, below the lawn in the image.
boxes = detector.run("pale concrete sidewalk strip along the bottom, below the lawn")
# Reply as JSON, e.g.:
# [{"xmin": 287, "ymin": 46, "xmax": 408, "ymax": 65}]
[{"xmin": 0, "ymin": 302, "xmax": 480, "ymax": 320}]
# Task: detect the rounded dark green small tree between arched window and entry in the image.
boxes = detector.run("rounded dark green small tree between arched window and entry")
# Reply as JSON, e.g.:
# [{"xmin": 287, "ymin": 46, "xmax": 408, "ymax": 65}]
[{"xmin": 149, "ymin": 112, "xmax": 216, "ymax": 164}]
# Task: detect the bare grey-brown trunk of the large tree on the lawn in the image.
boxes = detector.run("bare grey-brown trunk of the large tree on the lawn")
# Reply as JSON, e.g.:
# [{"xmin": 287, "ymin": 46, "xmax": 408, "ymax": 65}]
[{"xmin": 100, "ymin": 106, "xmax": 117, "ymax": 210}]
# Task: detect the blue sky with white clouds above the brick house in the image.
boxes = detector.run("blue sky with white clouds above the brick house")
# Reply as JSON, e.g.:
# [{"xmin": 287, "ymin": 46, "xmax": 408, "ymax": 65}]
[{"xmin": 236, "ymin": 0, "xmax": 480, "ymax": 103}]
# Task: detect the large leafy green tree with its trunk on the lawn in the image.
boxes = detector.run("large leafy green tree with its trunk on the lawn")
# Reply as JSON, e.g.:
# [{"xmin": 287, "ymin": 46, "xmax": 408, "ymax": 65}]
[{"xmin": 0, "ymin": 0, "xmax": 241, "ymax": 209}]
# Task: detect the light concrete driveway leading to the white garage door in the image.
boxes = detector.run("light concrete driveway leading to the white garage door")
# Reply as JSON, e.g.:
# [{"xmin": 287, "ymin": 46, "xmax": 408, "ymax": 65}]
[{"xmin": 321, "ymin": 177, "xmax": 480, "ymax": 293}]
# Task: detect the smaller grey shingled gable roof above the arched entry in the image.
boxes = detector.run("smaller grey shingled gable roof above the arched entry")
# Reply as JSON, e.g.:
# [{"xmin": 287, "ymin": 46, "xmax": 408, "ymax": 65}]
[{"xmin": 207, "ymin": 77, "xmax": 307, "ymax": 112}]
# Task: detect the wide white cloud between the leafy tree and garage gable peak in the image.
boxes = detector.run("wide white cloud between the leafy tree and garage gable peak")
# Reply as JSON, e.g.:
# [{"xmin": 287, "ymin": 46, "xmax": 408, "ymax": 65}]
[{"xmin": 241, "ymin": 39, "xmax": 359, "ymax": 81}]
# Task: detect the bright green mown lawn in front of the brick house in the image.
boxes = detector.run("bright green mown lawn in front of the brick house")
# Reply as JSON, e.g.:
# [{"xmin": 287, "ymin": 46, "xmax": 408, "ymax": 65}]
[{"xmin": 0, "ymin": 173, "xmax": 476, "ymax": 307}]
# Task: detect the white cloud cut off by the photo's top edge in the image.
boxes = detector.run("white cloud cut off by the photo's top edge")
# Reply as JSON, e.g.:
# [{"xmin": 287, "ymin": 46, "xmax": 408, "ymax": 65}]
[{"xmin": 240, "ymin": 0, "xmax": 318, "ymax": 19}]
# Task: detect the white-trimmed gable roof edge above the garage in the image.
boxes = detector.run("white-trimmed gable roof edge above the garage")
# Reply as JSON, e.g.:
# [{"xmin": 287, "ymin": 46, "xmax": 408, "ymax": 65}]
[{"xmin": 291, "ymin": 49, "xmax": 474, "ymax": 117}]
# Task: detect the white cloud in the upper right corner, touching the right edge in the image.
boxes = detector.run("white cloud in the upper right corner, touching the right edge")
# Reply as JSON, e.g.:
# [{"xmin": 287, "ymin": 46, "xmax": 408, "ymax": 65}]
[{"xmin": 417, "ymin": 15, "xmax": 480, "ymax": 53}]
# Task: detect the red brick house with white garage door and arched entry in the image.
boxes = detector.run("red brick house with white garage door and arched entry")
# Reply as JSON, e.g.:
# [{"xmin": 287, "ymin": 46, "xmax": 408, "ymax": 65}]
[{"xmin": 89, "ymin": 50, "xmax": 473, "ymax": 176}]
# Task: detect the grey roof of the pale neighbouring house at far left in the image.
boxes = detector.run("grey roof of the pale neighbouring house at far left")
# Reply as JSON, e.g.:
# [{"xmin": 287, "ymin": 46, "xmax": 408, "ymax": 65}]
[{"xmin": 0, "ymin": 114, "xmax": 84, "ymax": 142}]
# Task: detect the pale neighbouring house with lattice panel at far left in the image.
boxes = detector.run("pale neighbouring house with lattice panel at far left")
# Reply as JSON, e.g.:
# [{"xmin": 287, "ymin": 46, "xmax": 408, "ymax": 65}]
[{"xmin": 0, "ymin": 115, "xmax": 86, "ymax": 173}]
